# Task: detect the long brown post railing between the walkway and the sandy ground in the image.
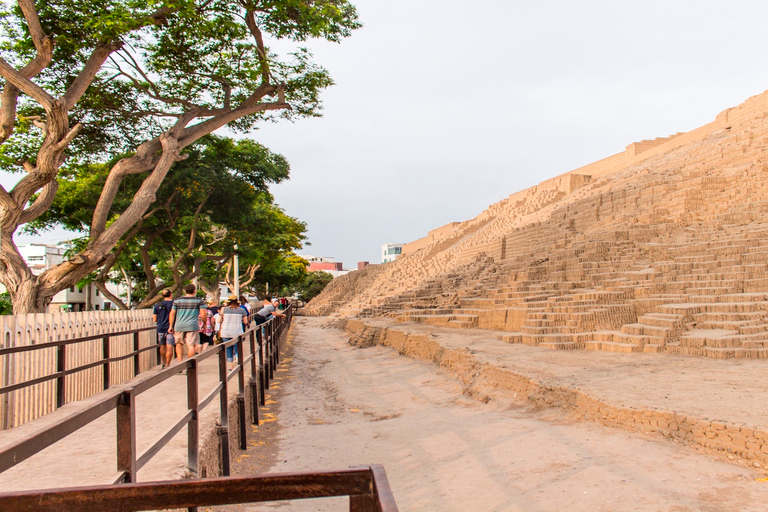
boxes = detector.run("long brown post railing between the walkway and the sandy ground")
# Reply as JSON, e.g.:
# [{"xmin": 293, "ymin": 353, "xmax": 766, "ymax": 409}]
[{"xmin": 0, "ymin": 307, "xmax": 292, "ymax": 484}]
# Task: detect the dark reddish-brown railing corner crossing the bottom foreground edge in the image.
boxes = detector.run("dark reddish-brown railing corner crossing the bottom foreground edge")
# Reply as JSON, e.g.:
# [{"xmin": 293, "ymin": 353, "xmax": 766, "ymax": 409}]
[{"xmin": 0, "ymin": 465, "xmax": 397, "ymax": 512}]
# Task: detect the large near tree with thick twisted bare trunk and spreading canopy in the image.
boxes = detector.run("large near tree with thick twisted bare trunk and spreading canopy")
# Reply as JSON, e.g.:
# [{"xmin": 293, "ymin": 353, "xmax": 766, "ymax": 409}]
[{"xmin": 0, "ymin": 0, "xmax": 360, "ymax": 313}]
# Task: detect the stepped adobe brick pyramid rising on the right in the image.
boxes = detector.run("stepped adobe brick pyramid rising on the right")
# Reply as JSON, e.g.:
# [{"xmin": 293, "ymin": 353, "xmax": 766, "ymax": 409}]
[{"xmin": 305, "ymin": 91, "xmax": 768, "ymax": 358}]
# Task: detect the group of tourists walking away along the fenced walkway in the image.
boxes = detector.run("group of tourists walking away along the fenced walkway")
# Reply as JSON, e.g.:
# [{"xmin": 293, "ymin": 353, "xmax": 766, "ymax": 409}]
[{"xmin": 152, "ymin": 284, "xmax": 288, "ymax": 370}]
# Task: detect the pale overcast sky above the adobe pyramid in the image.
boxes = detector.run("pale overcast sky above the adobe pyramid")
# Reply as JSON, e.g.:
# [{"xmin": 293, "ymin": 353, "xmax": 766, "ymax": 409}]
[{"xmin": 12, "ymin": 0, "xmax": 768, "ymax": 268}]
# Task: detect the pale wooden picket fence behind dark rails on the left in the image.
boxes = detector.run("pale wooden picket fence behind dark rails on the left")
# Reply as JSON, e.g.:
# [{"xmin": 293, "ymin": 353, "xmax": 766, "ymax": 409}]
[{"xmin": 0, "ymin": 309, "xmax": 157, "ymax": 430}]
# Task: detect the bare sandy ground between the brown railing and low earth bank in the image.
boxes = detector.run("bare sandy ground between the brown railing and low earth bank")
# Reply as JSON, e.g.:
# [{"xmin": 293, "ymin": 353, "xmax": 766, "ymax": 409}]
[{"xmin": 216, "ymin": 318, "xmax": 768, "ymax": 512}]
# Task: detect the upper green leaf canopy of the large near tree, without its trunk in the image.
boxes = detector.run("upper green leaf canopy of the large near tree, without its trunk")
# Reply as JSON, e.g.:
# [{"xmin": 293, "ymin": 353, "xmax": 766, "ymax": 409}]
[{"xmin": 0, "ymin": 0, "xmax": 361, "ymax": 171}]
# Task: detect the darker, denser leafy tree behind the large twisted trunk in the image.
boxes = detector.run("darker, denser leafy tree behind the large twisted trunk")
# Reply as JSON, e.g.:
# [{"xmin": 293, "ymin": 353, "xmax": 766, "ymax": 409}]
[{"xmin": 26, "ymin": 135, "xmax": 306, "ymax": 309}]
